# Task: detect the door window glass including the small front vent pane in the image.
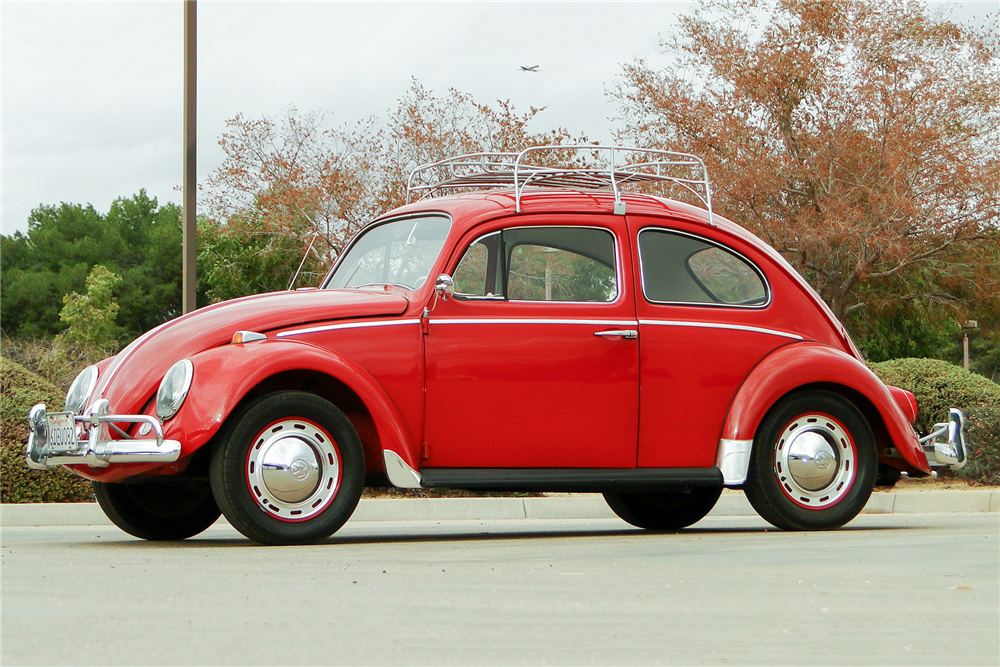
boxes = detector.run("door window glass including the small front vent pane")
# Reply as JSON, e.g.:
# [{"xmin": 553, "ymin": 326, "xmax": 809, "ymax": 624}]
[{"xmin": 452, "ymin": 227, "xmax": 618, "ymax": 302}]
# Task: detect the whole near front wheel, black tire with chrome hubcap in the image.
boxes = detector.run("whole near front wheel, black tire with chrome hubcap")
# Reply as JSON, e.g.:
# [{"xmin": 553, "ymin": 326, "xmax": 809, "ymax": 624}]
[{"xmin": 210, "ymin": 391, "xmax": 365, "ymax": 544}]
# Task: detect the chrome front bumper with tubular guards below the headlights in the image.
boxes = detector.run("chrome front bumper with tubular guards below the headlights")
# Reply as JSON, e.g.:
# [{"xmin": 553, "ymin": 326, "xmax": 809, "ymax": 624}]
[{"xmin": 25, "ymin": 399, "xmax": 181, "ymax": 470}]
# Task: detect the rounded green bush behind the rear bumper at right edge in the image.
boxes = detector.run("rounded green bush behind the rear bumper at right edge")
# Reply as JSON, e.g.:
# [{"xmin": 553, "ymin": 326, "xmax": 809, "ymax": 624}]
[{"xmin": 871, "ymin": 359, "xmax": 1000, "ymax": 484}]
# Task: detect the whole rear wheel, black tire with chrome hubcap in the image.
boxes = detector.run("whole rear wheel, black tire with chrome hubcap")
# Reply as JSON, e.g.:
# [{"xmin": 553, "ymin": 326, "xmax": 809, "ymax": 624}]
[{"xmin": 744, "ymin": 390, "xmax": 878, "ymax": 530}]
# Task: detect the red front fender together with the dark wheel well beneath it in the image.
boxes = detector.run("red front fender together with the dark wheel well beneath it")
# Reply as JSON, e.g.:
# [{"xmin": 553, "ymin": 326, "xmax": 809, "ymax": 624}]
[{"xmin": 164, "ymin": 340, "xmax": 419, "ymax": 478}]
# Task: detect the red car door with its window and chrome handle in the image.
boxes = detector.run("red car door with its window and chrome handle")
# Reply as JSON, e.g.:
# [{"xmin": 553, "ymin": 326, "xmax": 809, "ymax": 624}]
[{"xmin": 424, "ymin": 215, "xmax": 639, "ymax": 468}]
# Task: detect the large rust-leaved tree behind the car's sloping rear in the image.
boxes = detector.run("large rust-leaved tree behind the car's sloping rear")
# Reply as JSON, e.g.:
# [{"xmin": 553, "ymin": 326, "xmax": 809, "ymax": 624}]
[{"xmin": 612, "ymin": 0, "xmax": 1000, "ymax": 350}]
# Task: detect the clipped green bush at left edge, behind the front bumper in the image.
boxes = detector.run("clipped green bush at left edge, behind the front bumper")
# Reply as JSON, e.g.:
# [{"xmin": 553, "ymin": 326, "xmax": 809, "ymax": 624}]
[{"xmin": 0, "ymin": 357, "xmax": 94, "ymax": 503}]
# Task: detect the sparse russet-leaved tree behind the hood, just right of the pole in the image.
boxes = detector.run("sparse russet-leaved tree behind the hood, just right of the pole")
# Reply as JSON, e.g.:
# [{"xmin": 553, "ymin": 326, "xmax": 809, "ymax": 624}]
[{"xmin": 199, "ymin": 80, "xmax": 586, "ymax": 299}]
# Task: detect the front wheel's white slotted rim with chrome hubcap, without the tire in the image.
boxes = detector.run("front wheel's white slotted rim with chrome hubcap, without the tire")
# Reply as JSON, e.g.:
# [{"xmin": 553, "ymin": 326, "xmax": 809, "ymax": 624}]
[{"xmin": 244, "ymin": 417, "xmax": 342, "ymax": 522}]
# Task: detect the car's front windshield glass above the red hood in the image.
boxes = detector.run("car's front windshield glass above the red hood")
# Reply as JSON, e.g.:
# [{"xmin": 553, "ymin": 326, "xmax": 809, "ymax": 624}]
[{"xmin": 326, "ymin": 216, "xmax": 451, "ymax": 289}]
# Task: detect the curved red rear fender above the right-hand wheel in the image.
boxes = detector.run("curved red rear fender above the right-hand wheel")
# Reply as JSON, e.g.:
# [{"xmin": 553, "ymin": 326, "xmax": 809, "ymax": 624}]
[{"xmin": 722, "ymin": 342, "xmax": 930, "ymax": 474}]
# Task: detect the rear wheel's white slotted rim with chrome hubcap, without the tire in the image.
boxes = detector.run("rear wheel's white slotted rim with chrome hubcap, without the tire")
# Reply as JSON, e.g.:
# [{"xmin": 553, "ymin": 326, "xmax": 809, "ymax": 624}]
[{"xmin": 773, "ymin": 413, "xmax": 857, "ymax": 509}]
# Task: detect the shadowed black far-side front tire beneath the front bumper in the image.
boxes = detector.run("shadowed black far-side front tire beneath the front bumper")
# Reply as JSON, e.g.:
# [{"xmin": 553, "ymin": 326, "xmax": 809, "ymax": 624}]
[{"xmin": 94, "ymin": 480, "xmax": 220, "ymax": 540}]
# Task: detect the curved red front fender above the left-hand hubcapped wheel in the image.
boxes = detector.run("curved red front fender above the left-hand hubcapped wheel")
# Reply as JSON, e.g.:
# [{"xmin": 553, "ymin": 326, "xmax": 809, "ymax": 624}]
[{"xmin": 164, "ymin": 339, "xmax": 419, "ymax": 469}]
